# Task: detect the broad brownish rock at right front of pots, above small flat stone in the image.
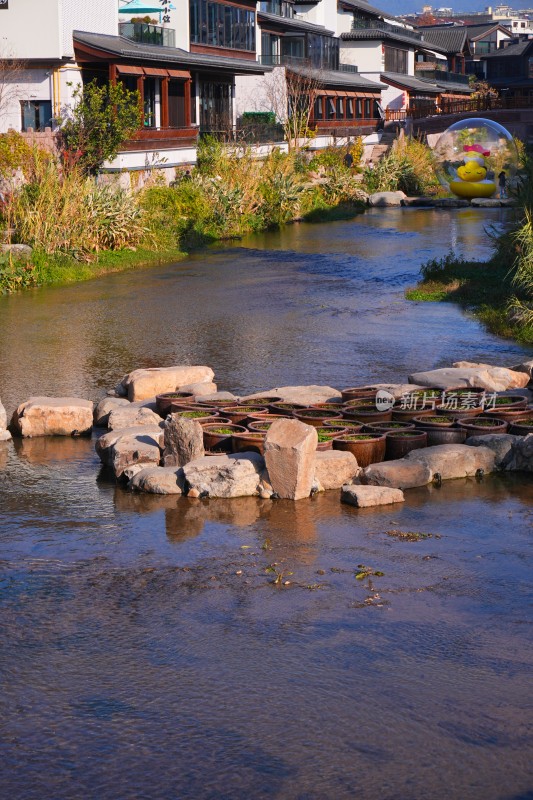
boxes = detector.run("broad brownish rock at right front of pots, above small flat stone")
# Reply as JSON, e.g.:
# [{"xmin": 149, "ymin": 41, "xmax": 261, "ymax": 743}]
[{"xmin": 406, "ymin": 444, "xmax": 496, "ymax": 481}]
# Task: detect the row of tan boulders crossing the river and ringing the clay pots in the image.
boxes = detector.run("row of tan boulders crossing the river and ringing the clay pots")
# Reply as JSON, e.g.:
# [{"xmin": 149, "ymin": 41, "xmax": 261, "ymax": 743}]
[{"xmin": 0, "ymin": 361, "xmax": 533, "ymax": 508}]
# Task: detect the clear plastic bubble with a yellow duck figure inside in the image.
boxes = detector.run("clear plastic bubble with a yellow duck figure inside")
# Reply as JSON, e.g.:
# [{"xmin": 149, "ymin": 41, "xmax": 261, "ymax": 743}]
[{"xmin": 434, "ymin": 118, "xmax": 518, "ymax": 199}]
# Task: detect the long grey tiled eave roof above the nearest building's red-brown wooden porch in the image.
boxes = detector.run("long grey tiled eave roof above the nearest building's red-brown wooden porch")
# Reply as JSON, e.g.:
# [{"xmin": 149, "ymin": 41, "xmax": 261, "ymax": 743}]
[{"xmin": 73, "ymin": 31, "xmax": 270, "ymax": 74}]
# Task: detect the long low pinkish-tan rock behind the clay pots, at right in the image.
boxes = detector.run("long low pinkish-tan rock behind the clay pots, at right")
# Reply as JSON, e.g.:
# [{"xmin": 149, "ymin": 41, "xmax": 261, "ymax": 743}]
[{"xmin": 409, "ymin": 361, "xmax": 529, "ymax": 392}]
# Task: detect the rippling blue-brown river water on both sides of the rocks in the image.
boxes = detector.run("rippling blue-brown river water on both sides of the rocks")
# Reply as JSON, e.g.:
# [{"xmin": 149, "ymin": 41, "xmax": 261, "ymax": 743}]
[{"xmin": 0, "ymin": 209, "xmax": 533, "ymax": 800}]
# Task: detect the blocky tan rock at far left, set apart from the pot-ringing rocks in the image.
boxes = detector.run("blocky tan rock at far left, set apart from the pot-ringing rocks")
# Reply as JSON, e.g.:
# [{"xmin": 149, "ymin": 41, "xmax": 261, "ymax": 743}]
[{"xmin": 11, "ymin": 397, "xmax": 93, "ymax": 437}]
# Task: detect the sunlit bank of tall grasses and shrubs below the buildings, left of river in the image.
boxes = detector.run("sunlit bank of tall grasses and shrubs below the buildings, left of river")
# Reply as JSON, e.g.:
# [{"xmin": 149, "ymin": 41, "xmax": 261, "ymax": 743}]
[{"xmin": 0, "ymin": 132, "xmax": 436, "ymax": 294}]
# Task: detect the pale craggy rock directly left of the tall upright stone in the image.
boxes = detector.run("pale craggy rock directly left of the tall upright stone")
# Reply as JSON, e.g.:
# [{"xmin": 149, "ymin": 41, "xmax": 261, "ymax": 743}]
[{"xmin": 183, "ymin": 453, "xmax": 265, "ymax": 497}]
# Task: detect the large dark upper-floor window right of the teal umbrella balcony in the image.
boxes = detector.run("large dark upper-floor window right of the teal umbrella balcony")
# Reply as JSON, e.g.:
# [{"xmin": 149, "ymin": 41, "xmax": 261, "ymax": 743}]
[{"xmin": 189, "ymin": 0, "xmax": 255, "ymax": 52}]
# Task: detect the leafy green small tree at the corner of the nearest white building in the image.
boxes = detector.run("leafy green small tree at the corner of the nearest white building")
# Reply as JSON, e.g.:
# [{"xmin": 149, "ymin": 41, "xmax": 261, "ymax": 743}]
[{"xmin": 59, "ymin": 81, "xmax": 142, "ymax": 174}]
